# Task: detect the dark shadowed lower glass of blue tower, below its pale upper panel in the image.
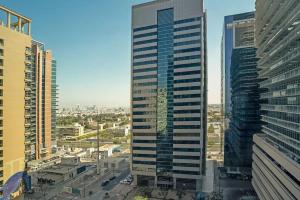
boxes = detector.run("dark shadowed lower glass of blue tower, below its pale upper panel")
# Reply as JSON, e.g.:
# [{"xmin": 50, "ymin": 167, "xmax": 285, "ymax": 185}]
[{"xmin": 224, "ymin": 46, "xmax": 260, "ymax": 168}]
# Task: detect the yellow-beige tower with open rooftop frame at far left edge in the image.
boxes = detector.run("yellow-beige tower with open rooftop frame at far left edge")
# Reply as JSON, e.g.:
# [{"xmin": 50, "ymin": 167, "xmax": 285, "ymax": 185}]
[{"xmin": 0, "ymin": 6, "xmax": 31, "ymax": 186}]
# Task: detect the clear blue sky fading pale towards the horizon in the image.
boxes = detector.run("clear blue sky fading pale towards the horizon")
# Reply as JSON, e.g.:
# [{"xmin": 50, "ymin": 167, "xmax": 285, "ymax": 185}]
[{"xmin": 0, "ymin": 0, "xmax": 255, "ymax": 106}]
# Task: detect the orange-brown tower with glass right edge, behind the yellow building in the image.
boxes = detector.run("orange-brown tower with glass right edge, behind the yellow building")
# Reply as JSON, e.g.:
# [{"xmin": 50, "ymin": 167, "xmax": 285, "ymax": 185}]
[{"xmin": 26, "ymin": 41, "xmax": 56, "ymax": 160}]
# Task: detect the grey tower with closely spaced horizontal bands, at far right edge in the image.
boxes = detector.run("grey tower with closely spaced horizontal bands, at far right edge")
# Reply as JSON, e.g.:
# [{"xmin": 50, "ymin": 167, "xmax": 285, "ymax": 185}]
[{"xmin": 252, "ymin": 0, "xmax": 300, "ymax": 199}]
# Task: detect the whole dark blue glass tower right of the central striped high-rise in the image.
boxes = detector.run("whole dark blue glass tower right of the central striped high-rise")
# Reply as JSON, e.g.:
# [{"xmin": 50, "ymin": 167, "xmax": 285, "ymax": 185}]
[{"xmin": 223, "ymin": 12, "xmax": 260, "ymax": 170}]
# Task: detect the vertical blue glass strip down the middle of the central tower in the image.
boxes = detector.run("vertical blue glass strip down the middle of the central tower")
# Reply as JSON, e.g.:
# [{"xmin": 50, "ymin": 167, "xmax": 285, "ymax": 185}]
[{"xmin": 156, "ymin": 9, "xmax": 174, "ymax": 176}]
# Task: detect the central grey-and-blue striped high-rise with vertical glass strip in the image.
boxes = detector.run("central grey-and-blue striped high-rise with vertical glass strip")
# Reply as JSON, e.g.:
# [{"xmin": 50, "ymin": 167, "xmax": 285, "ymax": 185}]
[{"xmin": 131, "ymin": 0, "xmax": 207, "ymax": 191}]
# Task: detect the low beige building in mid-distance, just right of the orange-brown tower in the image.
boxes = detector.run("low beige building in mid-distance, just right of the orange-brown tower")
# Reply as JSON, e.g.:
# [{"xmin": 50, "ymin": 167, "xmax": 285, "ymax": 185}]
[{"xmin": 57, "ymin": 123, "xmax": 84, "ymax": 139}]
